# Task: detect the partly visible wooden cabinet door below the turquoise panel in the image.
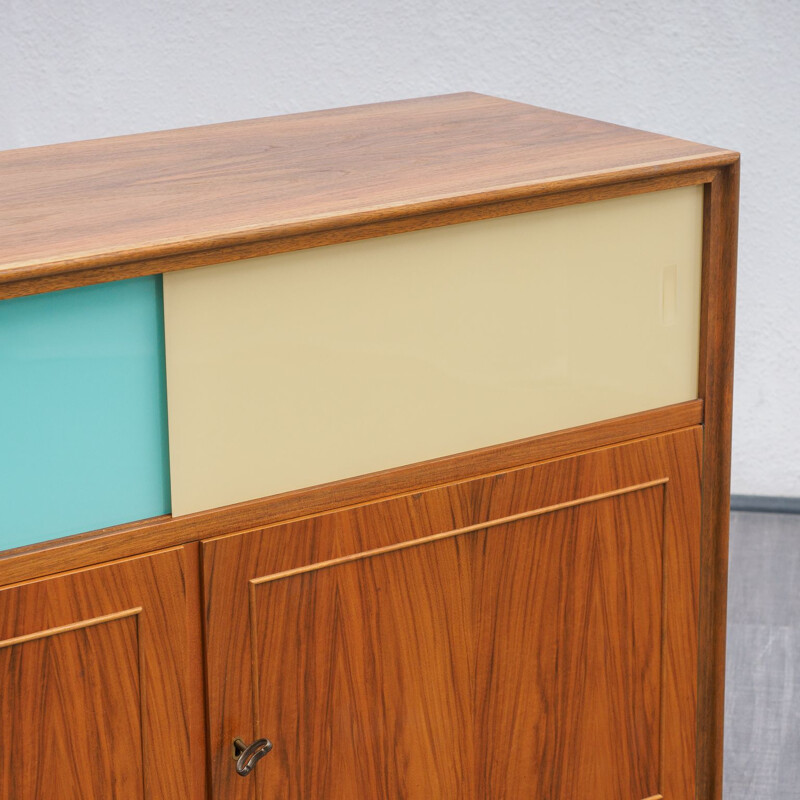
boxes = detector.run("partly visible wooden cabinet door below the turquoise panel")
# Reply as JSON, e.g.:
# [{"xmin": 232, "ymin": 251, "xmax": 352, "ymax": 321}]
[{"xmin": 0, "ymin": 548, "xmax": 202, "ymax": 800}]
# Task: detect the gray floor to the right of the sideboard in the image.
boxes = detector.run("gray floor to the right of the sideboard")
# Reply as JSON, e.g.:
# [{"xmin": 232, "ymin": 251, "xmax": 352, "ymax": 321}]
[{"xmin": 724, "ymin": 512, "xmax": 800, "ymax": 800}]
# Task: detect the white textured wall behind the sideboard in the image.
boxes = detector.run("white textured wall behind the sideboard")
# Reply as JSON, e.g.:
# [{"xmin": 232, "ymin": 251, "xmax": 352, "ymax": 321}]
[{"xmin": 0, "ymin": 0, "xmax": 800, "ymax": 496}]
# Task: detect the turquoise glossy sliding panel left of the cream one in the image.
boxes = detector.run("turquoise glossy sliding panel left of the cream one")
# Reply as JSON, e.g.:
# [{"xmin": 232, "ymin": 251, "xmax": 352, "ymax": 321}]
[{"xmin": 0, "ymin": 276, "xmax": 170, "ymax": 549}]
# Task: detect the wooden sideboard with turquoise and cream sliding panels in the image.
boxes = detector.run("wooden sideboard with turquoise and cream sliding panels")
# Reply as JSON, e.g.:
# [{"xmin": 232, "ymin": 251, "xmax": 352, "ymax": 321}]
[{"xmin": 0, "ymin": 93, "xmax": 739, "ymax": 800}]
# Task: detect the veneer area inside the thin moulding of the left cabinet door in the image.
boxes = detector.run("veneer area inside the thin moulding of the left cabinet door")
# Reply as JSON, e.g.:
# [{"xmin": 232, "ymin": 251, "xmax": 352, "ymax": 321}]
[{"xmin": 0, "ymin": 609, "xmax": 144, "ymax": 800}]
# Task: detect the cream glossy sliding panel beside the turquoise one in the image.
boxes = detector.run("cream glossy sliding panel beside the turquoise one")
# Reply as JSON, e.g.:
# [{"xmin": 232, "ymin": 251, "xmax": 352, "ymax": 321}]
[{"xmin": 164, "ymin": 187, "xmax": 703, "ymax": 514}]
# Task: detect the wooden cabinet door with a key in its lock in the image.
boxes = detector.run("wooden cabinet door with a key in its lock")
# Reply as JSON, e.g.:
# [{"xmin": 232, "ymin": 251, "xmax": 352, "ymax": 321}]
[{"xmin": 203, "ymin": 428, "xmax": 701, "ymax": 800}]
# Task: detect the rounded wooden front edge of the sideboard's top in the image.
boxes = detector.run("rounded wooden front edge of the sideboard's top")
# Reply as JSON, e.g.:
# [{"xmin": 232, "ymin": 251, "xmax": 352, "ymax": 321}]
[{"xmin": 0, "ymin": 164, "xmax": 724, "ymax": 300}]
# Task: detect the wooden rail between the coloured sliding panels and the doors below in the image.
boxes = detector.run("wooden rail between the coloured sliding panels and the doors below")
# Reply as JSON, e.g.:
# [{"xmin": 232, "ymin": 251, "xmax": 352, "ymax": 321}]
[{"xmin": 0, "ymin": 400, "xmax": 703, "ymax": 585}]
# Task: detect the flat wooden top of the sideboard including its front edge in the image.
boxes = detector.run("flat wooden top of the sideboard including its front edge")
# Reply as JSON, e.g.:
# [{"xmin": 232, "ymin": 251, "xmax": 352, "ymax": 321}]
[{"xmin": 0, "ymin": 93, "xmax": 738, "ymax": 298}]
